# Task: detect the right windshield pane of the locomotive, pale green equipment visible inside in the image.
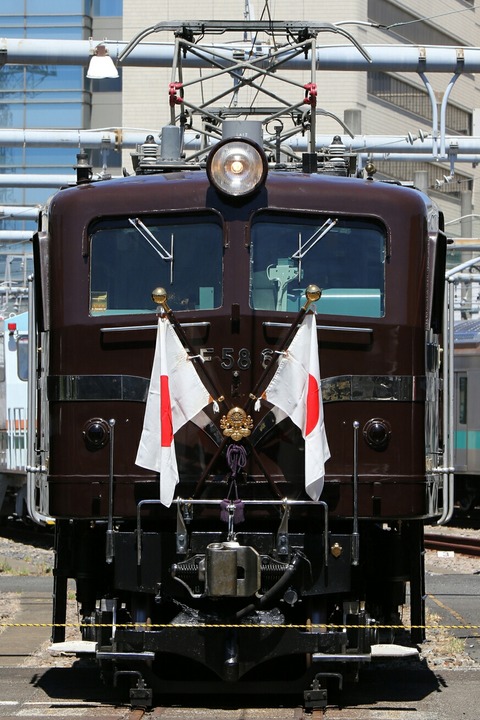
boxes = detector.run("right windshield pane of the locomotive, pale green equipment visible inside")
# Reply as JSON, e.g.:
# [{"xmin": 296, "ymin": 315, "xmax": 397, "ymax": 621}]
[{"xmin": 250, "ymin": 213, "xmax": 386, "ymax": 317}]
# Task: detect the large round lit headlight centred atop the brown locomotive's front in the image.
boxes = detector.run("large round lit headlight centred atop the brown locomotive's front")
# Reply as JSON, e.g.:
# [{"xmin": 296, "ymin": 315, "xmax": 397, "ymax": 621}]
[{"xmin": 207, "ymin": 138, "xmax": 268, "ymax": 197}]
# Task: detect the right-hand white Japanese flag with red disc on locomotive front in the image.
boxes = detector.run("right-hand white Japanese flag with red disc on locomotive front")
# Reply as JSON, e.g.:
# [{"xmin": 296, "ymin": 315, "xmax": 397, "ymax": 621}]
[{"xmin": 263, "ymin": 312, "xmax": 330, "ymax": 500}]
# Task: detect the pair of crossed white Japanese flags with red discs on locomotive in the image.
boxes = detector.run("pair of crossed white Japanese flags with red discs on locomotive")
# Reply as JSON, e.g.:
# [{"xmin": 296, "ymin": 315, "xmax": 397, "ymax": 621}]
[{"xmin": 135, "ymin": 311, "xmax": 330, "ymax": 507}]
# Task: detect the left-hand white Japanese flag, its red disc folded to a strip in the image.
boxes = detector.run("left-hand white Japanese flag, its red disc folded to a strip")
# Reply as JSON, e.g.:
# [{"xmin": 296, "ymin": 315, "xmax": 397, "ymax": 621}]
[{"xmin": 135, "ymin": 318, "xmax": 211, "ymax": 507}]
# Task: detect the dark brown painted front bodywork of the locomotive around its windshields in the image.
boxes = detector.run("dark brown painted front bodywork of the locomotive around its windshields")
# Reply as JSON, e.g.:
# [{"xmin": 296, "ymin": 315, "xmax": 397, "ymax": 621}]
[{"xmin": 41, "ymin": 172, "xmax": 433, "ymax": 518}]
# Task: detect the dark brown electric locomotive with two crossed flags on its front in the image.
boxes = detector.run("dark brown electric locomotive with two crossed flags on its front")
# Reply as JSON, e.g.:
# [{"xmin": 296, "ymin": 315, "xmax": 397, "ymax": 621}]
[{"xmin": 29, "ymin": 21, "xmax": 445, "ymax": 707}]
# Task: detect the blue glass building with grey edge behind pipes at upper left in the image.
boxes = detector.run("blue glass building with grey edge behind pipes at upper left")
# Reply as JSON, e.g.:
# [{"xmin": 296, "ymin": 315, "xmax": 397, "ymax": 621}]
[{"xmin": 0, "ymin": 0, "xmax": 122, "ymax": 229}]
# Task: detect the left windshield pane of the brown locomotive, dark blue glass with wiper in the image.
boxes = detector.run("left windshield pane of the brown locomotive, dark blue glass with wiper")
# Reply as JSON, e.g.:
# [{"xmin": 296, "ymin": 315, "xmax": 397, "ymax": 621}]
[{"xmin": 90, "ymin": 214, "xmax": 223, "ymax": 315}]
